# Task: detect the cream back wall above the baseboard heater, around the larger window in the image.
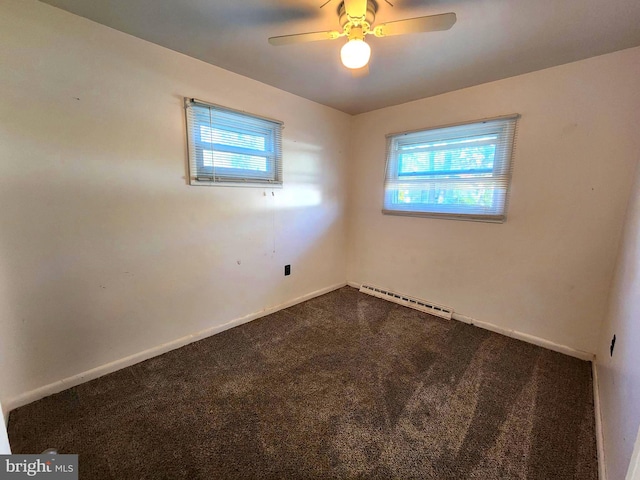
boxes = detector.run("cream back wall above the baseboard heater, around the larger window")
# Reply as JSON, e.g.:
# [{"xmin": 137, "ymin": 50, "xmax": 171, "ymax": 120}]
[{"xmin": 348, "ymin": 48, "xmax": 640, "ymax": 353}]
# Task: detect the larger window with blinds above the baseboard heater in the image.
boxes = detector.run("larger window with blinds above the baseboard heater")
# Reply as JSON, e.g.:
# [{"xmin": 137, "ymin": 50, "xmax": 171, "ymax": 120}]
[{"xmin": 382, "ymin": 115, "xmax": 518, "ymax": 222}]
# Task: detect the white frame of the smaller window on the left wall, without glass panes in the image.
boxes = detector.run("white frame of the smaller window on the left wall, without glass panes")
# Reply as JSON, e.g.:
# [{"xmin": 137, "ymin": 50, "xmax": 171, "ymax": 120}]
[{"xmin": 185, "ymin": 97, "xmax": 284, "ymax": 188}]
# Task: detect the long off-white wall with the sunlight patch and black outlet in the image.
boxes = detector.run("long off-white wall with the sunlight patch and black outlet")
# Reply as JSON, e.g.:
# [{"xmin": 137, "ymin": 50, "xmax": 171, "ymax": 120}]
[{"xmin": 0, "ymin": 0, "xmax": 351, "ymax": 408}]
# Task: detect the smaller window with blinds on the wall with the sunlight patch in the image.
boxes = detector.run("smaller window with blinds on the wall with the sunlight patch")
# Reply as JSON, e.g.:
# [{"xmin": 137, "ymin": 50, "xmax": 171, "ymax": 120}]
[{"xmin": 185, "ymin": 99, "xmax": 282, "ymax": 186}]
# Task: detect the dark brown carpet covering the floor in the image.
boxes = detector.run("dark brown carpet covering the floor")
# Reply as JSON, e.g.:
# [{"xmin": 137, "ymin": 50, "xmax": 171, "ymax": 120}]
[{"xmin": 9, "ymin": 287, "xmax": 597, "ymax": 480}]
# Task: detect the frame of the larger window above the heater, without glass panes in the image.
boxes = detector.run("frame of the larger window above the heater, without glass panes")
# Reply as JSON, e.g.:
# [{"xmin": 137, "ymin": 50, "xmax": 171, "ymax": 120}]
[{"xmin": 382, "ymin": 114, "xmax": 520, "ymax": 223}]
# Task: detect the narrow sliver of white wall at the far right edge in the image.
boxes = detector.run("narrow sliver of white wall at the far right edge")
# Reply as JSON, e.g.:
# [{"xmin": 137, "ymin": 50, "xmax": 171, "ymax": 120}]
[{"xmin": 596, "ymin": 158, "xmax": 640, "ymax": 480}]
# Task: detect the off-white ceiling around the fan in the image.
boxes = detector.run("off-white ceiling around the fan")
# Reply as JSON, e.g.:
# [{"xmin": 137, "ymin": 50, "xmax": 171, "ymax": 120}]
[{"xmin": 41, "ymin": 0, "xmax": 640, "ymax": 114}]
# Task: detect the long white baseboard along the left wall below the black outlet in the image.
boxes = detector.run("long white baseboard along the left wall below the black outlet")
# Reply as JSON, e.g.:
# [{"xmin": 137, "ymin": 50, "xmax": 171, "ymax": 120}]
[{"xmin": 4, "ymin": 282, "xmax": 346, "ymax": 412}]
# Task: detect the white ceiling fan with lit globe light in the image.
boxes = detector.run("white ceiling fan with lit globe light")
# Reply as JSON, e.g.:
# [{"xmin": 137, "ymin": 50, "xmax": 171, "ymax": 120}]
[{"xmin": 269, "ymin": 0, "xmax": 456, "ymax": 70}]
